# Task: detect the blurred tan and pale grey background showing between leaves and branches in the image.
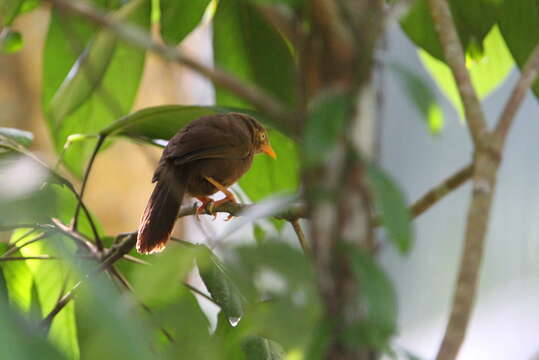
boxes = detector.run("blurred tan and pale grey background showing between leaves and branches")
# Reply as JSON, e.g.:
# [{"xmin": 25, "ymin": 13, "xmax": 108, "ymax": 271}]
[{"xmin": 4, "ymin": 3, "xmax": 539, "ymax": 360}]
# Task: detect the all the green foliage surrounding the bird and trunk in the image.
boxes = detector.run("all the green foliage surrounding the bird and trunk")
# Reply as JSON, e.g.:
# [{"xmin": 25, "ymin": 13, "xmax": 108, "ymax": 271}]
[{"xmin": 0, "ymin": 0, "xmax": 539, "ymax": 360}]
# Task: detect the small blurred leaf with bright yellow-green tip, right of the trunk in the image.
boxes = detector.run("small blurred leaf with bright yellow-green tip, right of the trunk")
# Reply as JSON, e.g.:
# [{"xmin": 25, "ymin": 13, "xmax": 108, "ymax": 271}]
[{"xmin": 389, "ymin": 62, "xmax": 444, "ymax": 135}]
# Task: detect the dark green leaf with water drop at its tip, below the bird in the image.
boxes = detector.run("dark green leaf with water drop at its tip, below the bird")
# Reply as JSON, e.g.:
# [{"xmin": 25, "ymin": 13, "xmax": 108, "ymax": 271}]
[{"xmin": 198, "ymin": 245, "xmax": 243, "ymax": 319}]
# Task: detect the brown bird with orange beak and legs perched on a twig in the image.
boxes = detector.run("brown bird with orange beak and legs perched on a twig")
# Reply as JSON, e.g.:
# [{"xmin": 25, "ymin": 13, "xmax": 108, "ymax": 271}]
[{"xmin": 137, "ymin": 113, "xmax": 276, "ymax": 254}]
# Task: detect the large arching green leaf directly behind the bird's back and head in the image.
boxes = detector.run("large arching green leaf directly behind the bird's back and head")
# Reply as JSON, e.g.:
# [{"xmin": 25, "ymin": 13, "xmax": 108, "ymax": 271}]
[{"xmin": 101, "ymin": 105, "xmax": 299, "ymax": 201}]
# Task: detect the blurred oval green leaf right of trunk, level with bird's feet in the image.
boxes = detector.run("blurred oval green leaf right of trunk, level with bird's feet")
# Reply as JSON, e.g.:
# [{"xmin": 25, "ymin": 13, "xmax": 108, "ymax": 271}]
[{"xmin": 367, "ymin": 165, "xmax": 413, "ymax": 253}]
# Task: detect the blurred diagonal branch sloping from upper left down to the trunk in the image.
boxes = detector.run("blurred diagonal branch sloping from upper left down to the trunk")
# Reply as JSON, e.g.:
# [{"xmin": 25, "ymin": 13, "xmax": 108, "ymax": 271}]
[{"xmin": 49, "ymin": 0, "xmax": 290, "ymax": 129}]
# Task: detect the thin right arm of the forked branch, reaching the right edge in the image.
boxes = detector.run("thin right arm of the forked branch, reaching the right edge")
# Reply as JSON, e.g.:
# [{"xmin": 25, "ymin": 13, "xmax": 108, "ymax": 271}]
[{"xmin": 494, "ymin": 44, "xmax": 539, "ymax": 146}]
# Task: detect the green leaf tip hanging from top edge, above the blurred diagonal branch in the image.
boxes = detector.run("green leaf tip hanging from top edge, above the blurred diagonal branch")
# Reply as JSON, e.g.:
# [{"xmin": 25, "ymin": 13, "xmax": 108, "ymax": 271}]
[{"xmin": 159, "ymin": 0, "xmax": 211, "ymax": 45}]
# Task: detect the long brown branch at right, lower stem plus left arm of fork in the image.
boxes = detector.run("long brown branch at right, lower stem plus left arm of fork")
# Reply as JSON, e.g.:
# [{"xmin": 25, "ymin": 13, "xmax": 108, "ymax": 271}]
[{"xmin": 429, "ymin": 0, "xmax": 502, "ymax": 360}]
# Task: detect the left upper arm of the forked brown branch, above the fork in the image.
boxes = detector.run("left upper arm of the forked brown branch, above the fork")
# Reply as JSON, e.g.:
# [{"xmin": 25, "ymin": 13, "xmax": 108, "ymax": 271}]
[{"xmin": 428, "ymin": 0, "xmax": 487, "ymax": 148}]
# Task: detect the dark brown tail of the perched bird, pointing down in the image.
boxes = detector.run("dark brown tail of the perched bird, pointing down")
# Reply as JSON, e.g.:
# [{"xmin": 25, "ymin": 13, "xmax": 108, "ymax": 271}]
[{"xmin": 137, "ymin": 169, "xmax": 185, "ymax": 254}]
